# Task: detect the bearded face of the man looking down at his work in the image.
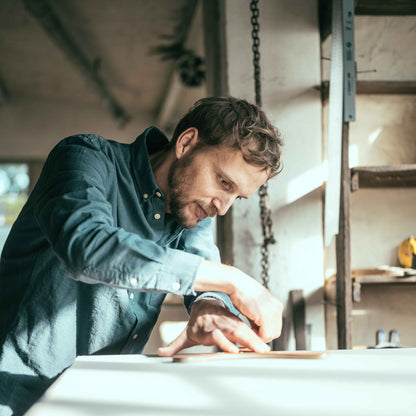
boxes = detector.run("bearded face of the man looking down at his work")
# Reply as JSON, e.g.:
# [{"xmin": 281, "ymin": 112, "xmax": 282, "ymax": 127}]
[{"xmin": 167, "ymin": 143, "xmax": 267, "ymax": 228}]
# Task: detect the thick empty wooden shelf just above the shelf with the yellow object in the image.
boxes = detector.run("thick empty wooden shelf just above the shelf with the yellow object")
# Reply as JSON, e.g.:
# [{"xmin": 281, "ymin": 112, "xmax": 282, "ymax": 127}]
[{"xmin": 351, "ymin": 164, "xmax": 416, "ymax": 192}]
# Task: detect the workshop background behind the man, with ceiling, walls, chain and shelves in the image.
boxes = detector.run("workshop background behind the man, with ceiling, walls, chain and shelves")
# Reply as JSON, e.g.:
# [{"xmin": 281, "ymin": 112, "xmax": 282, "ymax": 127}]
[{"xmin": 0, "ymin": 0, "xmax": 416, "ymax": 354}]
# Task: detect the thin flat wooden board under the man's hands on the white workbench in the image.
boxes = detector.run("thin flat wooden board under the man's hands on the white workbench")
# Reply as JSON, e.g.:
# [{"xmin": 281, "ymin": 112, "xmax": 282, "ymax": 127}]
[{"xmin": 173, "ymin": 349, "xmax": 327, "ymax": 363}]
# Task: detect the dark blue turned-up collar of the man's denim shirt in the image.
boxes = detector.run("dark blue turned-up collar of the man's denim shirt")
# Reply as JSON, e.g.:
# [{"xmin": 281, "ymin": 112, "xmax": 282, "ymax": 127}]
[{"xmin": 132, "ymin": 127, "xmax": 169, "ymax": 196}]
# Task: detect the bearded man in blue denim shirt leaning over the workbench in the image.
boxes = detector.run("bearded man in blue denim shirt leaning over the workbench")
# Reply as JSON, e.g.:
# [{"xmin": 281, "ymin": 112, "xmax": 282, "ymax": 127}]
[{"xmin": 0, "ymin": 97, "xmax": 282, "ymax": 416}]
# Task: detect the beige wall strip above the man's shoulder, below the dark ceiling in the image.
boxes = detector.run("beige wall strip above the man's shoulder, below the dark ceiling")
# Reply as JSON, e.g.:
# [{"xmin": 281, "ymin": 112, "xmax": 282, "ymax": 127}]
[{"xmin": 0, "ymin": 97, "xmax": 153, "ymax": 160}]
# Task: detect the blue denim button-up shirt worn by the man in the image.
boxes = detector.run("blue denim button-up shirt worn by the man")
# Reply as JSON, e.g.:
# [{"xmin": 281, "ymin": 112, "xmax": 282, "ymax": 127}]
[{"xmin": 0, "ymin": 127, "xmax": 235, "ymax": 416}]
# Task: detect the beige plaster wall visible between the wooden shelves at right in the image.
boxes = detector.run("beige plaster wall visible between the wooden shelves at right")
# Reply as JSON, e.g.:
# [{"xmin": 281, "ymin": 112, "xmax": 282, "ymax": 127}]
[{"xmin": 322, "ymin": 16, "xmax": 416, "ymax": 348}]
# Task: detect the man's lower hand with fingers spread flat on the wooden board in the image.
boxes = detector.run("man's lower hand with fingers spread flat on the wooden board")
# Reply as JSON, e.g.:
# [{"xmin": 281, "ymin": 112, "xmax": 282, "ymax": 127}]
[{"xmin": 157, "ymin": 298, "xmax": 270, "ymax": 356}]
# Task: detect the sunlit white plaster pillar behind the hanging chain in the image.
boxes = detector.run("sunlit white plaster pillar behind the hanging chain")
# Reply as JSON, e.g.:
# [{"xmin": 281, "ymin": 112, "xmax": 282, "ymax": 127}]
[{"xmin": 226, "ymin": 0, "xmax": 325, "ymax": 349}]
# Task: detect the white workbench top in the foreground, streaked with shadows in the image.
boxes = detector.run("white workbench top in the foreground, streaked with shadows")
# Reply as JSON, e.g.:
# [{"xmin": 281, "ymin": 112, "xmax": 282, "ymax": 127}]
[{"xmin": 26, "ymin": 348, "xmax": 416, "ymax": 416}]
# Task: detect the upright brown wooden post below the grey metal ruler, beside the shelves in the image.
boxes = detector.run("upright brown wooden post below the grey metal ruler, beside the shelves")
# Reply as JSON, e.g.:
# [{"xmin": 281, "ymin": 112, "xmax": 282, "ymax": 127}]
[{"xmin": 336, "ymin": 122, "xmax": 352, "ymax": 349}]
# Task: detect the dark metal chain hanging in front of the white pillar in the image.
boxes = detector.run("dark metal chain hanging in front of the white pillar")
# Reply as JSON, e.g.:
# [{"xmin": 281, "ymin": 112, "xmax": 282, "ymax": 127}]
[{"xmin": 250, "ymin": 0, "xmax": 276, "ymax": 289}]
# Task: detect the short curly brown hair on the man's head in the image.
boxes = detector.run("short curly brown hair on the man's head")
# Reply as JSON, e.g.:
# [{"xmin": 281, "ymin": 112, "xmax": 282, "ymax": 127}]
[{"xmin": 171, "ymin": 97, "xmax": 283, "ymax": 178}]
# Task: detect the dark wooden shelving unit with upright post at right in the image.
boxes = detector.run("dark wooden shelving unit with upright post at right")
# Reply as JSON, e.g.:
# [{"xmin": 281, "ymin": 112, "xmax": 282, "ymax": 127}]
[{"xmin": 319, "ymin": 0, "xmax": 416, "ymax": 349}]
